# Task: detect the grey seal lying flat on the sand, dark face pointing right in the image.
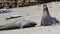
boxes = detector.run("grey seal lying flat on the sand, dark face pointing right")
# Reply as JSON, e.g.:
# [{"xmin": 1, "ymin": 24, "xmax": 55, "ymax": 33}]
[{"xmin": 0, "ymin": 20, "xmax": 37, "ymax": 31}]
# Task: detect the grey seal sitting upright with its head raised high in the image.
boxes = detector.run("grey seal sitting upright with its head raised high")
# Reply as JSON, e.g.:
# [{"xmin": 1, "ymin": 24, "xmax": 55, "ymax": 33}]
[{"xmin": 41, "ymin": 4, "xmax": 59, "ymax": 26}]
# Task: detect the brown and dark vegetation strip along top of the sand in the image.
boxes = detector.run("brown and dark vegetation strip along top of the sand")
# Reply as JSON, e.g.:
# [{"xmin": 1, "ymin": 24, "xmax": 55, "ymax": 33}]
[{"xmin": 0, "ymin": 0, "xmax": 59, "ymax": 8}]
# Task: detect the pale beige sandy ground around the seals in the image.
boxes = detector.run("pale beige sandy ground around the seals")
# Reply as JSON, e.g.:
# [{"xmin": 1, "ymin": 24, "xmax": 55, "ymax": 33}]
[{"xmin": 0, "ymin": 2, "xmax": 60, "ymax": 34}]
